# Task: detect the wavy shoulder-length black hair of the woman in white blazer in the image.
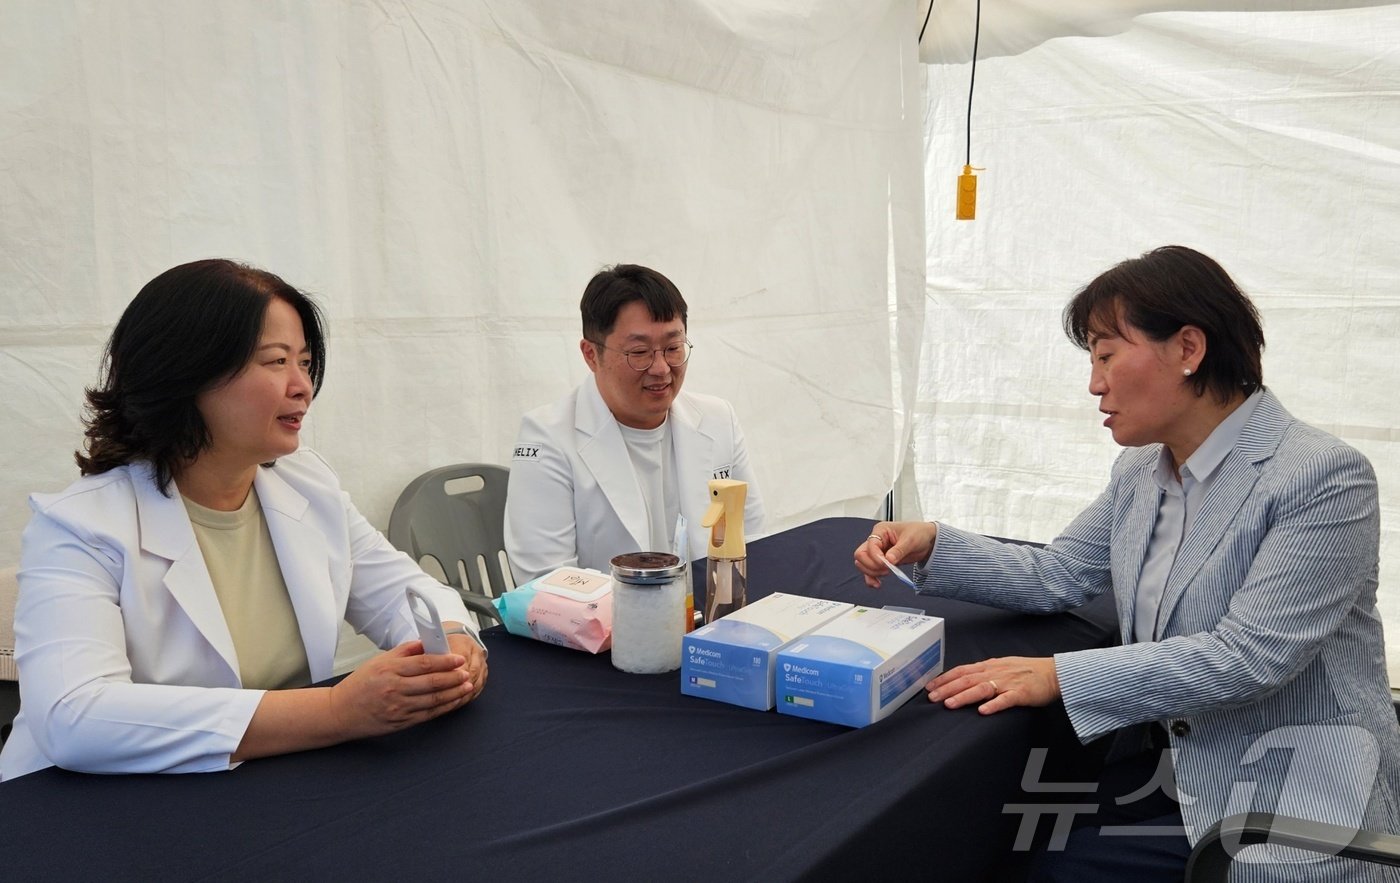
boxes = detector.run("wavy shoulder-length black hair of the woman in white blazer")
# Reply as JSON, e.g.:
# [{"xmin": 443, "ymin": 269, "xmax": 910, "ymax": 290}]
[{"xmin": 74, "ymin": 259, "xmax": 326, "ymax": 495}]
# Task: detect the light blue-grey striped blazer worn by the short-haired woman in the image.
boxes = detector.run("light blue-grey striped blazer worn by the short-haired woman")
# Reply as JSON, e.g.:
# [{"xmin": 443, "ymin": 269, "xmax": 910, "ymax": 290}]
[{"xmin": 918, "ymin": 392, "xmax": 1400, "ymax": 882}]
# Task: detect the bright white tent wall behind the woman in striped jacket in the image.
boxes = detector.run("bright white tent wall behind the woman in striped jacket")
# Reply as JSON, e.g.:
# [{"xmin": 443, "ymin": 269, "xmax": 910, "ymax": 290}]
[{"xmin": 904, "ymin": 0, "xmax": 1400, "ymax": 683}]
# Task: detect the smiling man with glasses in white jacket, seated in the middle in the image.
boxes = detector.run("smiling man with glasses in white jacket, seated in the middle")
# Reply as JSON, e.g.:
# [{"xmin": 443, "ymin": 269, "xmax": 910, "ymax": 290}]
[{"xmin": 505, "ymin": 264, "xmax": 763, "ymax": 584}]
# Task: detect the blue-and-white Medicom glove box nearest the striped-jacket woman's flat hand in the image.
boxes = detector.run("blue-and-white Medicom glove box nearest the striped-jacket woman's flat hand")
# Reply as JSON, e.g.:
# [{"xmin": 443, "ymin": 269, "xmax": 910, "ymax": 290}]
[{"xmin": 777, "ymin": 607, "xmax": 944, "ymax": 726}]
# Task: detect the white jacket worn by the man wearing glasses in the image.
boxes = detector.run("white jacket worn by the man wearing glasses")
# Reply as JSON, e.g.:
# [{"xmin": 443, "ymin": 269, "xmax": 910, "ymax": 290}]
[{"xmin": 505, "ymin": 375, "xmax": 763, "ymax": 584}]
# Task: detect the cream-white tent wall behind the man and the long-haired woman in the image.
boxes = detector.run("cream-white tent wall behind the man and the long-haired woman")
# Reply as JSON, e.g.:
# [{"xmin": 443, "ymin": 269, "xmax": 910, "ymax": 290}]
[{"xmin": 0, "ymin": 0, "xmax": 924, "ymax": 567}]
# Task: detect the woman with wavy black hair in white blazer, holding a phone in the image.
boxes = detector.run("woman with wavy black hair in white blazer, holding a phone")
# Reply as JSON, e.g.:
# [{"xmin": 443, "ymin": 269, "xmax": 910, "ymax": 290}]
[{"xmin": 0, "ymin": 260, "xmax": 486, "ymax": 779}]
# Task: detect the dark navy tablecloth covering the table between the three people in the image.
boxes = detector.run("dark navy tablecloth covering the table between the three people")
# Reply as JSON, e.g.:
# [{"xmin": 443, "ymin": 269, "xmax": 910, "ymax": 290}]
[{"xmin": 0, "ymin": 518, "xmax": 1116, "ymax": 883}]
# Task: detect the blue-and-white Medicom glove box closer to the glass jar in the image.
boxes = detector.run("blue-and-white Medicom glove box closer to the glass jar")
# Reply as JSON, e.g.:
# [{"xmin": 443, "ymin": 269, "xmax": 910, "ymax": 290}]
[{"xmin": 680, "ymin": 592, "xmax": 853, "ymax": 711}]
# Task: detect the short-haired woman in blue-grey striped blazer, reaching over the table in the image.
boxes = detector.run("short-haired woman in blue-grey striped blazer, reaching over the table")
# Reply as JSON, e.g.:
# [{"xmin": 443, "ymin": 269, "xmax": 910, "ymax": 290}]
[{"xmin": 855, "ymin": 246, "xmax": 1400, "ymax": 883}]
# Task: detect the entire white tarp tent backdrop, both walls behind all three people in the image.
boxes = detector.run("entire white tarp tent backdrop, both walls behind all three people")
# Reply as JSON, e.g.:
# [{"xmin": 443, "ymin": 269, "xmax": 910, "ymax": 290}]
[{"xmin": 0, "ymin": 0, "xmax": 1400, "ymax": 680}]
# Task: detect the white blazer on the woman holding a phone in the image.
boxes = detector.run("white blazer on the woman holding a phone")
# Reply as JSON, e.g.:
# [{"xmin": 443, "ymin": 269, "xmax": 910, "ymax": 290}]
[{"xmin": 0, "ymin": 449, "xmax": 470, "ymax": 779}]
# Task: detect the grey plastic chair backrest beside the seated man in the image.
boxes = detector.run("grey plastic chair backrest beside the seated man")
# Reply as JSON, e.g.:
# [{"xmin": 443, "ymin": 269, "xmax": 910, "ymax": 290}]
[{"xmin": 389, "ymin": 463, "xmax": 515, "ymax": 614}]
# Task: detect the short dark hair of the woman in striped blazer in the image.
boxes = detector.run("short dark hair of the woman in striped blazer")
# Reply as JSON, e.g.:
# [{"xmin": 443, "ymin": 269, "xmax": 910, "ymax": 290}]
[{"xmin": 1063, "ymin": 245, "xmax": 1264, "ymax": 403}]
